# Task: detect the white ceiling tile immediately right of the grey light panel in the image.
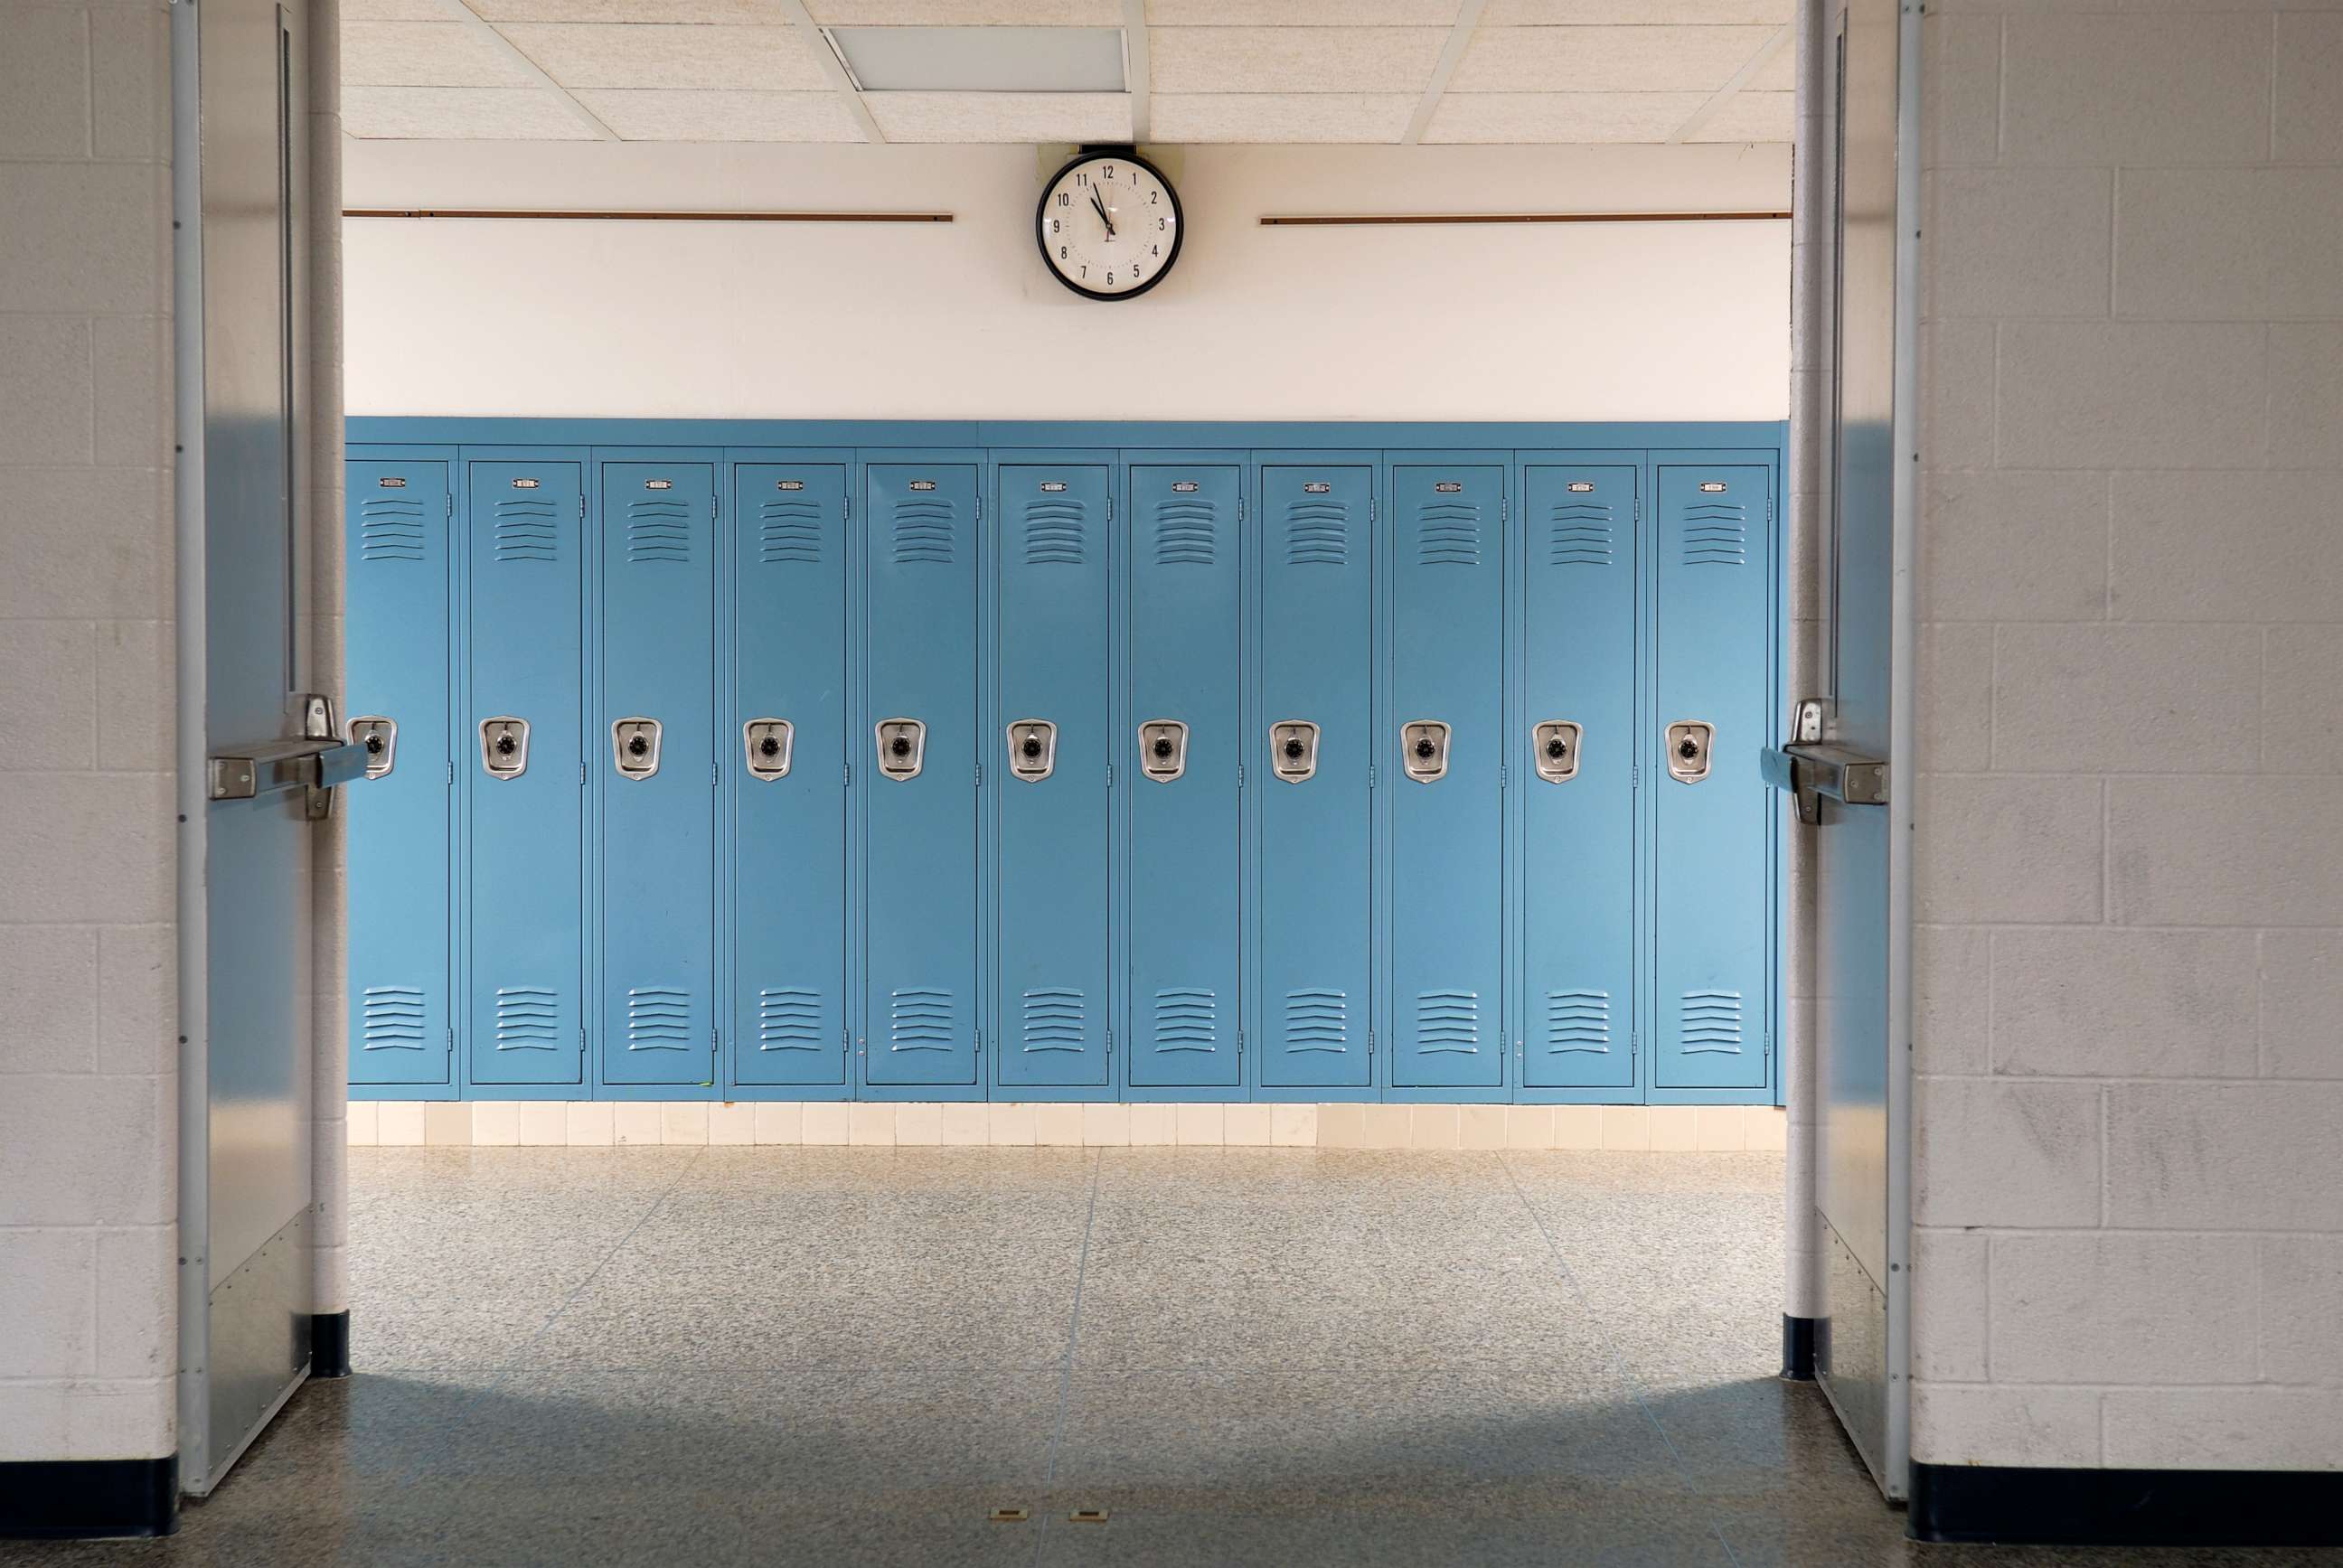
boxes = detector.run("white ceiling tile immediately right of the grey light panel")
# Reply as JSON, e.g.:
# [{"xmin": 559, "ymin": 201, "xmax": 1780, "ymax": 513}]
[{"xmin": 1148, "ymin": 28, "xmax": 1448, "ymax": 94}]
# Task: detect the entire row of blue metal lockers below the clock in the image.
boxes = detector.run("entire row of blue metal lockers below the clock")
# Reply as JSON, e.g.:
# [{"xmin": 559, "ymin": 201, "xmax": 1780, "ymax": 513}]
[{"xmin": 344, "ymin": 419, "xmax": 1783, "ymax": 1102}]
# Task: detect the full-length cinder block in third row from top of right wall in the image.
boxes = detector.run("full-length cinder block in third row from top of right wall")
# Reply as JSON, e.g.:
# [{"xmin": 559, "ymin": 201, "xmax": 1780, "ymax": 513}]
[{"xmin": 1994, "ymin": 321, "xmax": 2268, "ymax": 464}]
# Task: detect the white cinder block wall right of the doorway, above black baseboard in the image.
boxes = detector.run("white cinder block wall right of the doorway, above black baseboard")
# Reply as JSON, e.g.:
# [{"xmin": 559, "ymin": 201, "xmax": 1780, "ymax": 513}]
[{"xmin": 1912, "ymin": 0, "xmax": 2343, "ymax": 1469}]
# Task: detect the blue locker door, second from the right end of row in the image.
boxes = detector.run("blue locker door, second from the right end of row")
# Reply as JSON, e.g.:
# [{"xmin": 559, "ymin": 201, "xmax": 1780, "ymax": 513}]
[{"xmin": 1509, "ymin": 464, "xmax": 1640, "ymax": 1090}]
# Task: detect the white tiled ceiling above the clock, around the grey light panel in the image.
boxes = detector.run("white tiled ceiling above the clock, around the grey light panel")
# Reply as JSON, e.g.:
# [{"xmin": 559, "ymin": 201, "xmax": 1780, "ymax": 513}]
[{"xmin": 342, "ymin": 0, "xmax": 1793, "ymax": 143}]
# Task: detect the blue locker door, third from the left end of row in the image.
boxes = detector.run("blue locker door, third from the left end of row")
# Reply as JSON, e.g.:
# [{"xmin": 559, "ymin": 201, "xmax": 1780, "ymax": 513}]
[{"xmin": 593, "ymin": 462, "xmax": 717, "ymax": 1085}]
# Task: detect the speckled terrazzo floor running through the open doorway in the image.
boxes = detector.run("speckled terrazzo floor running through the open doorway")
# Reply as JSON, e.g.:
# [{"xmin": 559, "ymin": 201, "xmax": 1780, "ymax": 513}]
[{"xmin": 0, "ymin": 1149, "xmax": 2303, "ymax": 1568}]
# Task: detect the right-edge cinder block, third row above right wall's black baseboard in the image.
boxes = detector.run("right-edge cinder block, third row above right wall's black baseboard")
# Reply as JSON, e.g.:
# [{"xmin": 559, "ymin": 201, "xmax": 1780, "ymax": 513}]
[{"xmin": 2106, "ymin": 1081, "xmax": 2343, "ymax": 1231}]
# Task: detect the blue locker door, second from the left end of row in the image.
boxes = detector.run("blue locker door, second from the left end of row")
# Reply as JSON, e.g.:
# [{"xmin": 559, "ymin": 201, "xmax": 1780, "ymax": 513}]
[{"xmin": 456, "ymin": 459, "xmax": 586, "ymax": 1083}]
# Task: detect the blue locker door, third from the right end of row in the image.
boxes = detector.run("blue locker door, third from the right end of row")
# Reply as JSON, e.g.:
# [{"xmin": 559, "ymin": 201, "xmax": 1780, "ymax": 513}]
[{"xmin": 1382, "ymin": 464, "xmax": 1509, "ymax": 1090}]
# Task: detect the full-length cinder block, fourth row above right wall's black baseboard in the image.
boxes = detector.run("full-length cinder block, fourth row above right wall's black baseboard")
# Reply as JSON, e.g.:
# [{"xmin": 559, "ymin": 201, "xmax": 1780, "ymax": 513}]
[{"xmin": 1991, "ymin": 928, "xmax": 2259, "ymax": 1078}]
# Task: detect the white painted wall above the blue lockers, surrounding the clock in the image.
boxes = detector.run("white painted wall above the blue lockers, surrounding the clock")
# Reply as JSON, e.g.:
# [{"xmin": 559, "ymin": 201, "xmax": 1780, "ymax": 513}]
[{"xmin": 344, "ymin": 141, "xmax": 1790, "ymax": 419}]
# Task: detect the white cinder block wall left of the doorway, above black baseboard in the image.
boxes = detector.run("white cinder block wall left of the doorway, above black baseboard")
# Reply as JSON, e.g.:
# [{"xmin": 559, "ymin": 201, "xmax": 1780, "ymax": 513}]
[{"xmin": 0, "ymin": 0, "xmax": 178, "ymax": 1462}]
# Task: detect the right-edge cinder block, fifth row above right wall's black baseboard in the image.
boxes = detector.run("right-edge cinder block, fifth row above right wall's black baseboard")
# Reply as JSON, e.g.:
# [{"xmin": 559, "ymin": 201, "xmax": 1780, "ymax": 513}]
[{"xmin": 2106, "ymin": 773, "xmax": 2343, "ymax": 925}]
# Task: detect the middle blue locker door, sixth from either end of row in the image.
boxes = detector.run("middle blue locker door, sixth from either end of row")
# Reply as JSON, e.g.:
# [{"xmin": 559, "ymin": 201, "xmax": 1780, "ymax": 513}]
[{"xmin": 993, "ymin": 464, "xmax": 1113, "ymax": 1087}]
